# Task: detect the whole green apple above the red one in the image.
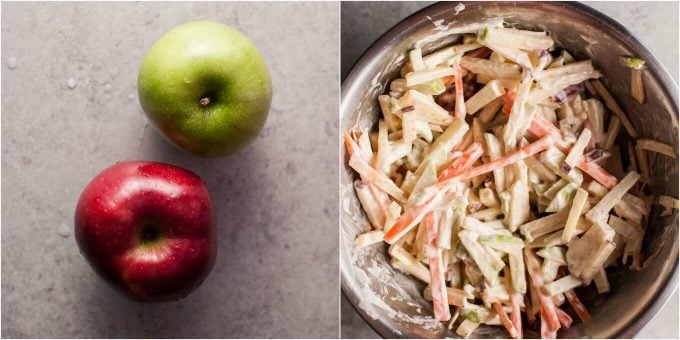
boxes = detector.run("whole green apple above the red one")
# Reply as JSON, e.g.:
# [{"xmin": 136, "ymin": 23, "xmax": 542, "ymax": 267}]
[{"xmin": 137, "ymin": 21, "xmax": 272, "ymax": 157}]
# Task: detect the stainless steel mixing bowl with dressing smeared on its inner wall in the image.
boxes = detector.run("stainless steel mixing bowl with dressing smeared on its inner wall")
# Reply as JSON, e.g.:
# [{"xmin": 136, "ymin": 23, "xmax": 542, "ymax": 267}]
[{"xmin": 340, "ymin": 2, "xmax": 678, "ymax": 338}]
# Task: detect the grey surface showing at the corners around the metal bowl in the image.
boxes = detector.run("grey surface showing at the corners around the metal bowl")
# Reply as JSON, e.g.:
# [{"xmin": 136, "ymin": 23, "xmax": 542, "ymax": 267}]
[{"xmin": 340, "ymin": 1, "xmax": 678, "ymax": 339}]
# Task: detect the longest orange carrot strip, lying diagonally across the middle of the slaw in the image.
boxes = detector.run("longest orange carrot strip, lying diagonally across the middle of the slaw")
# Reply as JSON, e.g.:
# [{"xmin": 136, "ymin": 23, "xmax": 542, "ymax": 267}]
[{"xmin": 385, "ymin": 136, "xmax": 554, "ymax": 244}]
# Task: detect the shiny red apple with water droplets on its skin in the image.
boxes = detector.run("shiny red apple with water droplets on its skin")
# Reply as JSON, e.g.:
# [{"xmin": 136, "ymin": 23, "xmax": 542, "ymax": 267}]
[{"xmin": 75, "ymin": 161, "xmax": 217, "ymax": 301}]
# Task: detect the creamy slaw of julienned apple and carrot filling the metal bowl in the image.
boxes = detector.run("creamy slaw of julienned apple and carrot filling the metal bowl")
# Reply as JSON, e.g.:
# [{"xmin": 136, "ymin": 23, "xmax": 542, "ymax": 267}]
[{"xmin": 343, "ymin": 22, "xmax": 678, "ymax": 338}]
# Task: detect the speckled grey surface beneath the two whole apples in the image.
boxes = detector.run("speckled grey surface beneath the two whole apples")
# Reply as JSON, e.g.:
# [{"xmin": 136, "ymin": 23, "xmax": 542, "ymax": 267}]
[{"xmin": 0, "ymin": 2, "xmax": 339, "ymax": 338}]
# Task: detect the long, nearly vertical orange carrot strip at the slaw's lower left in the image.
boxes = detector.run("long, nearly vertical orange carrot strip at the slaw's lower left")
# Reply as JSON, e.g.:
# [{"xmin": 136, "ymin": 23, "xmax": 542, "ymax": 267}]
[{"xmin": 425, "ymin": 211, "xmax": 451, "ymax": 321}]
